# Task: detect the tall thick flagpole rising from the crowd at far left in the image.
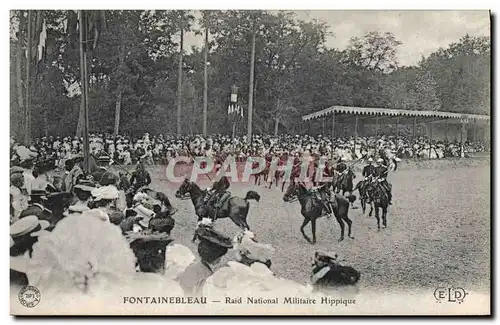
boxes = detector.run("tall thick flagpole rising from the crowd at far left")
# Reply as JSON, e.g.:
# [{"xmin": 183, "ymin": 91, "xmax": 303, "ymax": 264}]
[{"xmin": 78, "ymin": 10, "xmax": 89, "ymax": 173}]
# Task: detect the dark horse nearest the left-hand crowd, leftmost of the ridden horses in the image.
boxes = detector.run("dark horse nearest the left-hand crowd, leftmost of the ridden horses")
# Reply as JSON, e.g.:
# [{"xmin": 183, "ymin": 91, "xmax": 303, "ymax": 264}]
[{"xmin": 175, "ymin": 178, "xmax": 260, "ymax": 235}]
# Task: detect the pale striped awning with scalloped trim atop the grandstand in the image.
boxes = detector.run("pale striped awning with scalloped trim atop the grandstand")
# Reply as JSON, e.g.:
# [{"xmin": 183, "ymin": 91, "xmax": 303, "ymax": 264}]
[{"xmin": 302, "ymin": 106, "xmax": 490, "ymax": 122}]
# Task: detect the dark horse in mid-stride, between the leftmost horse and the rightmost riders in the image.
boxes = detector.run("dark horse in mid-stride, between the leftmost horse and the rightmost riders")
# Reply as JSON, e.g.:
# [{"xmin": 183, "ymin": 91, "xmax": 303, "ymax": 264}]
[{"xmin": 283, "ymin": 183, "xmax": 354, "ymax": 244}]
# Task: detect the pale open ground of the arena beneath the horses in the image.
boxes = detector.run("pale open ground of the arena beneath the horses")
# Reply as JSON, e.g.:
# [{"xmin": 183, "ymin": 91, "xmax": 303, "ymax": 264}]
[{"xmin": 133, "ymin": 162, "xmax": 491, "ymax": 292}]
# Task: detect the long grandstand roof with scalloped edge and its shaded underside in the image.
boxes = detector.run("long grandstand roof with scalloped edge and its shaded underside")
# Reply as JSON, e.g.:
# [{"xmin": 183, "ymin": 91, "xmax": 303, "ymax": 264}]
[{"xmin": 302, "ymin": 106, "xmax": 490, "ymax": 124}]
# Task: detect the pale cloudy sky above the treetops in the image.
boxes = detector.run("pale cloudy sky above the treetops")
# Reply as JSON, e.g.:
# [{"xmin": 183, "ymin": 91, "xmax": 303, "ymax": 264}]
[{"xmin": 185, "ymin": 10, "xmax": 490, "ymax": 66}]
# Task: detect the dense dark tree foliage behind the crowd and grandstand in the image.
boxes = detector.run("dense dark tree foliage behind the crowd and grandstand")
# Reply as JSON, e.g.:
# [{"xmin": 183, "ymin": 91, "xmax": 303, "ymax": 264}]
[{"xmin": 10, "ymin": 10, "xmax": 490, "ymax": 139}]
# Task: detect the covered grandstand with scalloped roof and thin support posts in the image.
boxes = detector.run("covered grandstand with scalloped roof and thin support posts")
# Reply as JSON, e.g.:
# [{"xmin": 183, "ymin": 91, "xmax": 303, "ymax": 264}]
[{"xmin": 302, "ymin": 106, "xmax": 490, "ymax": 157}]
